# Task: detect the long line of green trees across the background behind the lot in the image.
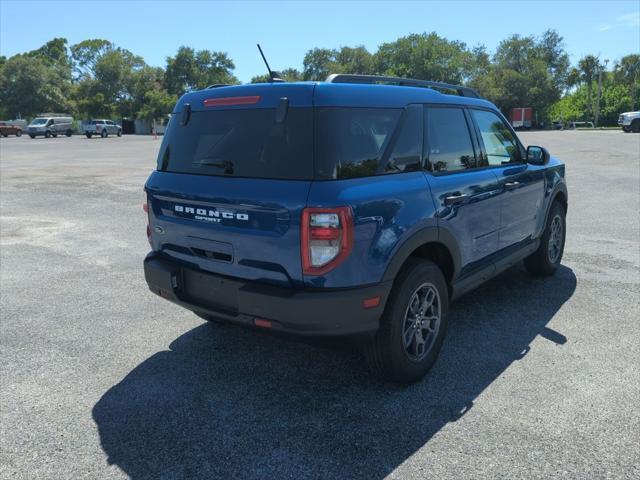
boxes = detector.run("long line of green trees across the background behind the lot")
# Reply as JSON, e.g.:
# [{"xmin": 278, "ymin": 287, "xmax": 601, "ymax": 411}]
[{"xmin": 0, "ymin": 30, "xmax": 640, "ymax": 125}]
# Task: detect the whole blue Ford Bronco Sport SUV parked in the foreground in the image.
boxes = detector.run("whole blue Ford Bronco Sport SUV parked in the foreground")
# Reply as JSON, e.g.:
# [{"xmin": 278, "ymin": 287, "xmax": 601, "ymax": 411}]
[{"xmin": 144, "ymin": 75, "xmax": 567, "ymax": 382}]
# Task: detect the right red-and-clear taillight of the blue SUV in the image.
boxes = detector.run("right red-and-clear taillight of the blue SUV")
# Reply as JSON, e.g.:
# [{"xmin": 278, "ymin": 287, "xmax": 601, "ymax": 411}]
[{"xmin": 300, "ymin": 207, "xmax": 353, "ymax": 275}]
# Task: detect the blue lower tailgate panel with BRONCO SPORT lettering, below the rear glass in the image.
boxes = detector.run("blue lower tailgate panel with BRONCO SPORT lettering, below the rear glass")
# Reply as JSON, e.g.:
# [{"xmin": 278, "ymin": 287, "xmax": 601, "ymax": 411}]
[{"xmin": 147, "ymin": 172, "xmax": 310, "ymax": 287}]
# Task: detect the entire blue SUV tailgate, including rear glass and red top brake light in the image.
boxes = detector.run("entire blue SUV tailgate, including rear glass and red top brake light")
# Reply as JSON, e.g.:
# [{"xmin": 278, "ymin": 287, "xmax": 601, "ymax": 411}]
[{"xmin": 146, "ymin": 84, "xmax": 314, "ymax": 287}]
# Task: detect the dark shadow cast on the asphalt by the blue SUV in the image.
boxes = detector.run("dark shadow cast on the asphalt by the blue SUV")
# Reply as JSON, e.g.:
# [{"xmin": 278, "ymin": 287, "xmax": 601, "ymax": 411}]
[{"xmin": 93, "ymin": 267, "xmax": 576, "ymax": 479}]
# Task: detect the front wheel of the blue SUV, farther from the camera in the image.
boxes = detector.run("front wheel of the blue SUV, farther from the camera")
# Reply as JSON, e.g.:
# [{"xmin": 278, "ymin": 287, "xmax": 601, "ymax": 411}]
[{"xmin": 524, "ymin": 202, "xmax": 567, "ymax": 276}]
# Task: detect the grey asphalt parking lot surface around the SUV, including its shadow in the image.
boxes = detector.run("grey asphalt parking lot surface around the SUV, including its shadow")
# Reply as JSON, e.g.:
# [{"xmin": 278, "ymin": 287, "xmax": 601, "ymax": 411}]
[{"xmin": 0, "ymin": 130, "xmax": 640, "ymax": 479}]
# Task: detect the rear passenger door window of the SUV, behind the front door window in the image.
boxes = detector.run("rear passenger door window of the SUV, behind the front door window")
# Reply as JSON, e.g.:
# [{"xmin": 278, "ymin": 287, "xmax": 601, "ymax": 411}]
[{"xmin": 425, "ymin": 107, "xmax": 476, "ymax": 173}]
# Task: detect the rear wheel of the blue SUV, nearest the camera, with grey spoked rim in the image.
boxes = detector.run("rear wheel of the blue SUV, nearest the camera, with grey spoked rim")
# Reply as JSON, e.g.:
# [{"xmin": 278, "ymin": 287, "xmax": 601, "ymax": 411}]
[{"xmin": 364, "ymin": 257, "xmax": 449, "ymax": 383}]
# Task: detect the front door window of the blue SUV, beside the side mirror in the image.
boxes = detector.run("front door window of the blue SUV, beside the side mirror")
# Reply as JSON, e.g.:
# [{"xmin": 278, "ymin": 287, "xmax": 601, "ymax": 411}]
[{"xmin": 471, "ymin": 110, "xmax": 520, "ymax": 166}]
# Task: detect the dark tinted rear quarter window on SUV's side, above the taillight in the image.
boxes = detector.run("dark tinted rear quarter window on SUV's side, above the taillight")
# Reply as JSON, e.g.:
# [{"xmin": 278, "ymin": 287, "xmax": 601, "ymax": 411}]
[{"xmin": 315, "ymin": 107, "xmax": 402, "ymax": 179}]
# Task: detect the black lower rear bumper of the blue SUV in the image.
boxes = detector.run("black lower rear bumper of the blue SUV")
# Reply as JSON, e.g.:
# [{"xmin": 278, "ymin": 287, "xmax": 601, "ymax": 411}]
[{"xmin": 144, "ymin": 253, "xmax": 391, "ymax": 335}]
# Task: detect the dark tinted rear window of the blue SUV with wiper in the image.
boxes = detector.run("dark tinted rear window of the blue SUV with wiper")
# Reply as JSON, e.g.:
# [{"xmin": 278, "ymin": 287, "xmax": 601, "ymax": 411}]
[{"xmin": 158, "ymin": 108, "xmax": 313, "ymax": 180}]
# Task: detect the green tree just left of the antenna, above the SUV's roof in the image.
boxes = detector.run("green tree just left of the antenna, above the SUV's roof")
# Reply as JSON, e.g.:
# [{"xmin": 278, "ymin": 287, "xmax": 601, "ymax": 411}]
[{"xmin": 165, "ymin": 46, "xmax": 238, "ymax": 96}]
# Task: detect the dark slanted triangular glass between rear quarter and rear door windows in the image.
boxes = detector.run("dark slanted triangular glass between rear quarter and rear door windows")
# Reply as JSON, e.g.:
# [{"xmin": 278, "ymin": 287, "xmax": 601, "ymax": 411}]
[{"xmin": 385, "ymin": 105, "xmax": 423, "ymax": 173}]
